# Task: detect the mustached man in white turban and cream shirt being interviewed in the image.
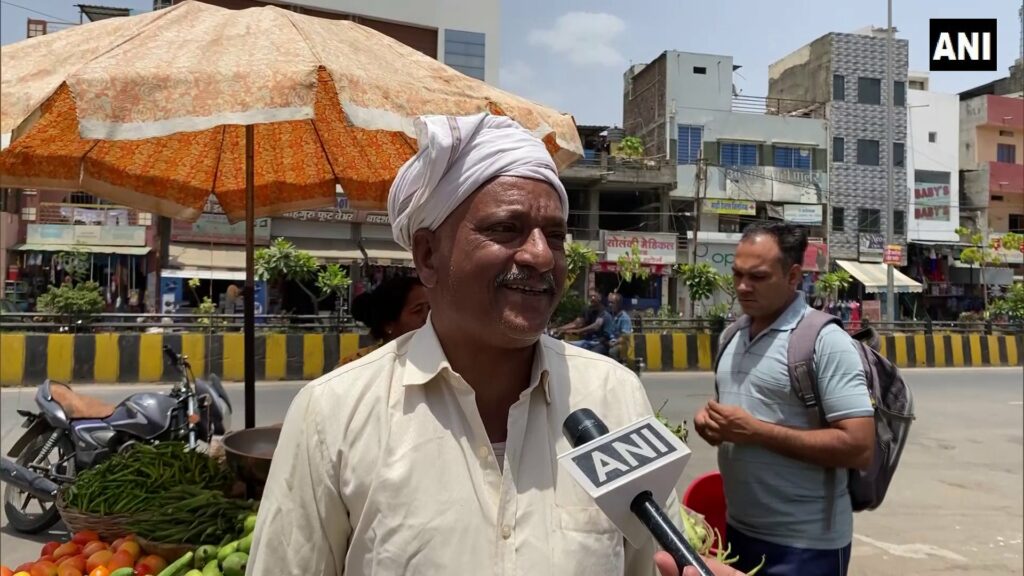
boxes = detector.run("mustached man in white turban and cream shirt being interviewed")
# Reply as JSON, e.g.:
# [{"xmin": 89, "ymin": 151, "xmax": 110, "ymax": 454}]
[{"xmin": 249, "ymin": 114, "xmax": 737, "ymax": 576}]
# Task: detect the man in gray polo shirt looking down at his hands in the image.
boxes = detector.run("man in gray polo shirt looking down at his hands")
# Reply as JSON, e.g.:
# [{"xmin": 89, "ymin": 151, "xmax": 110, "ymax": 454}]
[{"xmin": 694, "ymin": 222, "xmax": 874, "ymax": 576}]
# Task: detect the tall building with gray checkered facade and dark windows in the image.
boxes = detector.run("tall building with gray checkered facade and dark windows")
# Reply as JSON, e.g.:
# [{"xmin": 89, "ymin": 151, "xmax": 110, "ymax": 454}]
[{"xmin": 768, "ymin": 28, "xmax": 922, "ymax": 320}]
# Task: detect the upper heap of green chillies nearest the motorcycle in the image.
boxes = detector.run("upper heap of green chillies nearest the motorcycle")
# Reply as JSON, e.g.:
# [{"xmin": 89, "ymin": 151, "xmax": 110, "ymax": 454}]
[{"xmin": 63, "ymin": 442, "xmax": 234, "ymax": 515}]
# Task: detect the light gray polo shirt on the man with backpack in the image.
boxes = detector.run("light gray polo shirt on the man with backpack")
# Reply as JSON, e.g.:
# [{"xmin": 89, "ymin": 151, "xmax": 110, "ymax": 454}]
[{"xmin": 717, "ymin": 293, "xmax": 873, "ymax": 549}]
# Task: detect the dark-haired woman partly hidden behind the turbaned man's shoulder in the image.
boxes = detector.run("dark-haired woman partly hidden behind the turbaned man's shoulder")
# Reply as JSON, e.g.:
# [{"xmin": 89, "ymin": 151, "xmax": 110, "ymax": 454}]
[{"xmin": 336, "ymin": 276, "xmax": 430, "ymax": 368}]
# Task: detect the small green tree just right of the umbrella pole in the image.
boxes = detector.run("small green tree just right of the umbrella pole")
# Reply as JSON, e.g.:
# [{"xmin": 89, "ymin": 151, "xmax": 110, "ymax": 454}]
[{"xmin": 254, "ymin": 238, "xmax": 351, "ymax": 314}]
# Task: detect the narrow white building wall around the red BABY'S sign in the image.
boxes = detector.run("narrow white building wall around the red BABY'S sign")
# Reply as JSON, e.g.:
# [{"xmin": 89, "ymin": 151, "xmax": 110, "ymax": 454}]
[{"xmin": 906, "ymin": 90, "xmax": 961, "ymax": 242}]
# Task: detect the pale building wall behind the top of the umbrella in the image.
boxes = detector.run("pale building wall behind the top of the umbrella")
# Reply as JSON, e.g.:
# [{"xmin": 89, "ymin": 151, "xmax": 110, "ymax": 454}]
[{"xmin": 293, "ymin": 0, "xmax": 501, "ymax": 84}]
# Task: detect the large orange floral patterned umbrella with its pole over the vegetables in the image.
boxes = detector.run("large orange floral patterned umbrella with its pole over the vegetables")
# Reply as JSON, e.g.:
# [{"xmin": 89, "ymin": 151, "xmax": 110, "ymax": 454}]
[{"xmin": 0, "ymin": 1, "xmax": 583, "ymax": 427}]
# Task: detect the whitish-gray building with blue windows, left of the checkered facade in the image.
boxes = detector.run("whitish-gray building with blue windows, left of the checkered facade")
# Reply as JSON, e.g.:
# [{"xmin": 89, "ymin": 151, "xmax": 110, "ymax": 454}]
[{"xmin": 624, "ymin": 51, "xmax": 828, "ymax": 309}]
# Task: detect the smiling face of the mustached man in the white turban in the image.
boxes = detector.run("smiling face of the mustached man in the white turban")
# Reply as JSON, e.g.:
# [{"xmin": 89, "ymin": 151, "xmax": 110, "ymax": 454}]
[{"xmin": 414, "ymin": 176, "xmax": 566, "ymax": 347}]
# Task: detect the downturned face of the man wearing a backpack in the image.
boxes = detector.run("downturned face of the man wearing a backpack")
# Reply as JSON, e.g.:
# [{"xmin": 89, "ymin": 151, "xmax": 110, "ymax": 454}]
[{"xmin": 732, "ymin": 235, "xmax": 800, "ymax": 318}]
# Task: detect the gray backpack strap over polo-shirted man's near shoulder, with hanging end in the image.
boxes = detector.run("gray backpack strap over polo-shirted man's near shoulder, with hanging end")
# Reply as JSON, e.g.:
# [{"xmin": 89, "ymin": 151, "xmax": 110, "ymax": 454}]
[{"xmin": 787, "ymin": 308, "xmax": 843, "ymax": 530}]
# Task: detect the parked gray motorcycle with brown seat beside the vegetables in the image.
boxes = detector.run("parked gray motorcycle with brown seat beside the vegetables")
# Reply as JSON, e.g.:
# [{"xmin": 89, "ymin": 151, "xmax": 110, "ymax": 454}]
[{"xmin": 0, "ymin": 346, "xmax": 232, "ymax": 534}]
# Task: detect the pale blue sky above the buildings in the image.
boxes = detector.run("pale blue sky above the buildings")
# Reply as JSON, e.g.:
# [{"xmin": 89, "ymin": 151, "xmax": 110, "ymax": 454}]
[{"xmin": 0, "ymin": 0, "xmax": 1021, "ymax": 124}]
